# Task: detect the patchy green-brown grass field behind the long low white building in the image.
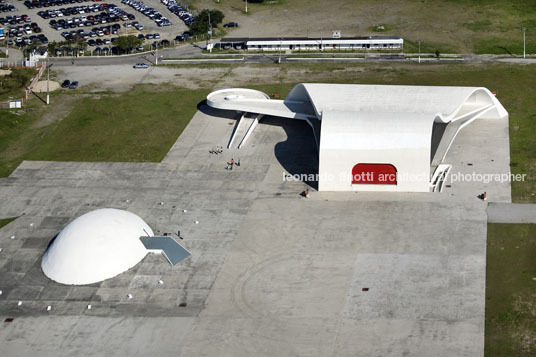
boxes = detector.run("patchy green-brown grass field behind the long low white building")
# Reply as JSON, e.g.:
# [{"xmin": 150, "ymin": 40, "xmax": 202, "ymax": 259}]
[{"xmin": 189, "ymin": 0, "xmax": 536, "ymax": 54}]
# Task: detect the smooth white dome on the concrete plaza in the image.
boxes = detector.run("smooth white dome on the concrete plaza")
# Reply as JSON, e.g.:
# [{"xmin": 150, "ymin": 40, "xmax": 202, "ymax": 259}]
[{"xmin": 41, "ymin": 208, "xmax": 153, "ymax": 285}]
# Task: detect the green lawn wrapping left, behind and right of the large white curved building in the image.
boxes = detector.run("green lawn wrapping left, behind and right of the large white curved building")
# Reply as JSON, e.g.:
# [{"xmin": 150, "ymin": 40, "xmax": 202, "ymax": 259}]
[{"xmin": 0, "ymin": 63, "xmax": 536, "ymax": 202}]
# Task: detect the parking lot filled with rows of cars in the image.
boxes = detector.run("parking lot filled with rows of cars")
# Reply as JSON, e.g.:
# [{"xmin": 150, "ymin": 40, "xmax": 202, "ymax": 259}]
[{"xmin": 0, "ymin": 0, "xmax": 188, "ymax": 55}]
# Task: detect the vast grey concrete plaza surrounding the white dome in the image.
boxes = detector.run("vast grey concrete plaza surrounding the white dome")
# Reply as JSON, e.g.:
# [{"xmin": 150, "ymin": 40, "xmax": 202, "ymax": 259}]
[{"xmin": 0, "ymin": 106, "xmax": 510, "ymax": 356}]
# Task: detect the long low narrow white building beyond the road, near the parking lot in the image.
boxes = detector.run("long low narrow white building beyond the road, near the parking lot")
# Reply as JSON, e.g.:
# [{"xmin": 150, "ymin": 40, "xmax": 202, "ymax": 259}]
[{"xmin": 220, "ymin": 36, "xmax": 404, "ymax": 51}]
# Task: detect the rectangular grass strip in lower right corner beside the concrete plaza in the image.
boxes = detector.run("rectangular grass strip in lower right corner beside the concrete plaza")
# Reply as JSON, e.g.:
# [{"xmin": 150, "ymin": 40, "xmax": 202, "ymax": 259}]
[{"xmin": 485, "ymin": 224, "xmax": 536, "ymax": 357}]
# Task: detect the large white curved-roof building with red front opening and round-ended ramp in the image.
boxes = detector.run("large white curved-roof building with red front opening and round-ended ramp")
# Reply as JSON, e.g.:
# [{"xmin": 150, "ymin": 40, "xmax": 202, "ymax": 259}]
[{"xmin": 207, "ymin": 84, "xmax": 508, "ymax": 192}]
